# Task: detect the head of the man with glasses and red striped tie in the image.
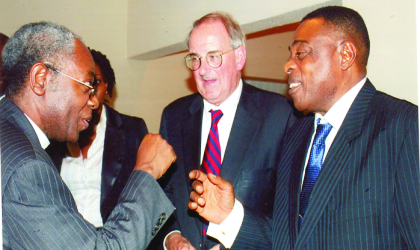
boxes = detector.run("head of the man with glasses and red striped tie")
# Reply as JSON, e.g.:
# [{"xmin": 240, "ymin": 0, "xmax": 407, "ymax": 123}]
[{"xmin": 185, "ymin": 12, "xmax": 246, "ymax": 105}]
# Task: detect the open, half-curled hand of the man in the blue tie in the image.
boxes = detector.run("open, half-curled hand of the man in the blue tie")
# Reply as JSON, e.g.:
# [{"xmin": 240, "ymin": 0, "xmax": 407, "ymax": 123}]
[{"xmin": 188, "ymin": 170, "xmax": 235, "ymax": 224}]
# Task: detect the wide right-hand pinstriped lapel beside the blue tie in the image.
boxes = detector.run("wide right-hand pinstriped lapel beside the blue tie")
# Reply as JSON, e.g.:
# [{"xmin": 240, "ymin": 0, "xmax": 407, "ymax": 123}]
[{"xmin": 296, "ymin": 80, "xmax": 376, "ymax": 249}]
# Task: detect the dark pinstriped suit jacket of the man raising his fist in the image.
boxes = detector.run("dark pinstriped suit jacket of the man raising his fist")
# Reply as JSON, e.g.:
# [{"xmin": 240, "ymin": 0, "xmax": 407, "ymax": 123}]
[{"xmin": 0, "ymin": 98, "xmax": 174, "ymax": 249}]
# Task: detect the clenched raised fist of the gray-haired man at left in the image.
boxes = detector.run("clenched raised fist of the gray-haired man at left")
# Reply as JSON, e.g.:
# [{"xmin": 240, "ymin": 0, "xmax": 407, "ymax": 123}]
[{"xmin": 134, "ymin": 134, "xmax": 176, "ymax": 180}]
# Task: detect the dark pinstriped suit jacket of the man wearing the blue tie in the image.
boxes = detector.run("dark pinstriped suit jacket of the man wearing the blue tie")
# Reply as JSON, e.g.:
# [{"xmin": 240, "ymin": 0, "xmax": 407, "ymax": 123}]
[{"xmin": 235, "ymin": 80, "xmax": 420, "ymax": 249}]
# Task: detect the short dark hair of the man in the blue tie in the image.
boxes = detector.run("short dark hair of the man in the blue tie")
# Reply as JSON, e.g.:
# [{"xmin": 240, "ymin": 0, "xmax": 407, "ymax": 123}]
[{"xmin": 302, "ymin": 6, "xmax": 370, "ymax": 66}]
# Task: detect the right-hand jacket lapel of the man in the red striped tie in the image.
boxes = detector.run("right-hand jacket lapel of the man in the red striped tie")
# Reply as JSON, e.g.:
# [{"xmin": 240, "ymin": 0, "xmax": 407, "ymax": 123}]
[{"xmin": 220, "ymin": 83, "xmax": 263, "ymax": 187}]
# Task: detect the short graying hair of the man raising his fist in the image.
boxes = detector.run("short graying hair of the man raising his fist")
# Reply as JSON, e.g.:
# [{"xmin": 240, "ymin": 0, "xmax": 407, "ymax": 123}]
[{"xmin": 2, "ymin": 22, "xmax": 82, "ymax": 97}]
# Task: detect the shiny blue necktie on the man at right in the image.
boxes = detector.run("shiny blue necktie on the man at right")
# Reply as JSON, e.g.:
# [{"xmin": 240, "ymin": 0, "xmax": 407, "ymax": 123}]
[{"xmin": 299, "ymin": 118, "xmax": 332, "ymax": 229}]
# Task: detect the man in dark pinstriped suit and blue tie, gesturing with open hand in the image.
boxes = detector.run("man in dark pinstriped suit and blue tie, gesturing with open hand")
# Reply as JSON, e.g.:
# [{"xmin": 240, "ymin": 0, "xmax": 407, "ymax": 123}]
[{"xmin": 190, "ymin": 6, "xmax": 420, "ymax": 249}]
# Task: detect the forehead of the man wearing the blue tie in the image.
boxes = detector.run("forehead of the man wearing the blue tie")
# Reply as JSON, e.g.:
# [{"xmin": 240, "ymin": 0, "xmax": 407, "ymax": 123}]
[{"xmin": 289, "ymin": 18, "xmax": 331, "ymax": 49}]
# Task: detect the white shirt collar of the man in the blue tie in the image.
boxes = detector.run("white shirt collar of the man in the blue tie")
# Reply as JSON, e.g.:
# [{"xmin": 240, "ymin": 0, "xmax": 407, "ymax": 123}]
[{"xmin": 315, "ymin": 77, "xmax": 367, "ymax": 130}]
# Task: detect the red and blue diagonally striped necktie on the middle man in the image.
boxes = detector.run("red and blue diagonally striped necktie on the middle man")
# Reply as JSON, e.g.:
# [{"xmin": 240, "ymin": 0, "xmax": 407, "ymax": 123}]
[{"xmin": 201, "ymin": 110, "xmax": 223, "ymax": 237}]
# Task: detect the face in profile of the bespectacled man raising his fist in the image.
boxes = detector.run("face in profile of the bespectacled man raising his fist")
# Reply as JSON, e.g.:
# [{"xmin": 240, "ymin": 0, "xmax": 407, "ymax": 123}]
[{"xmin": 41, "ymin": 39, "xmax": 98, "ymax": 142}]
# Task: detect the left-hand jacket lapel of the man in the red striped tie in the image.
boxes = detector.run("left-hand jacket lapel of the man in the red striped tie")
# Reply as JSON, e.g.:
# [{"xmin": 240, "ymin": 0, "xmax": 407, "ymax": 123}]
[{"xmin": 181, "ymin": 95, "xmax": 204, "ymax": 232}]
